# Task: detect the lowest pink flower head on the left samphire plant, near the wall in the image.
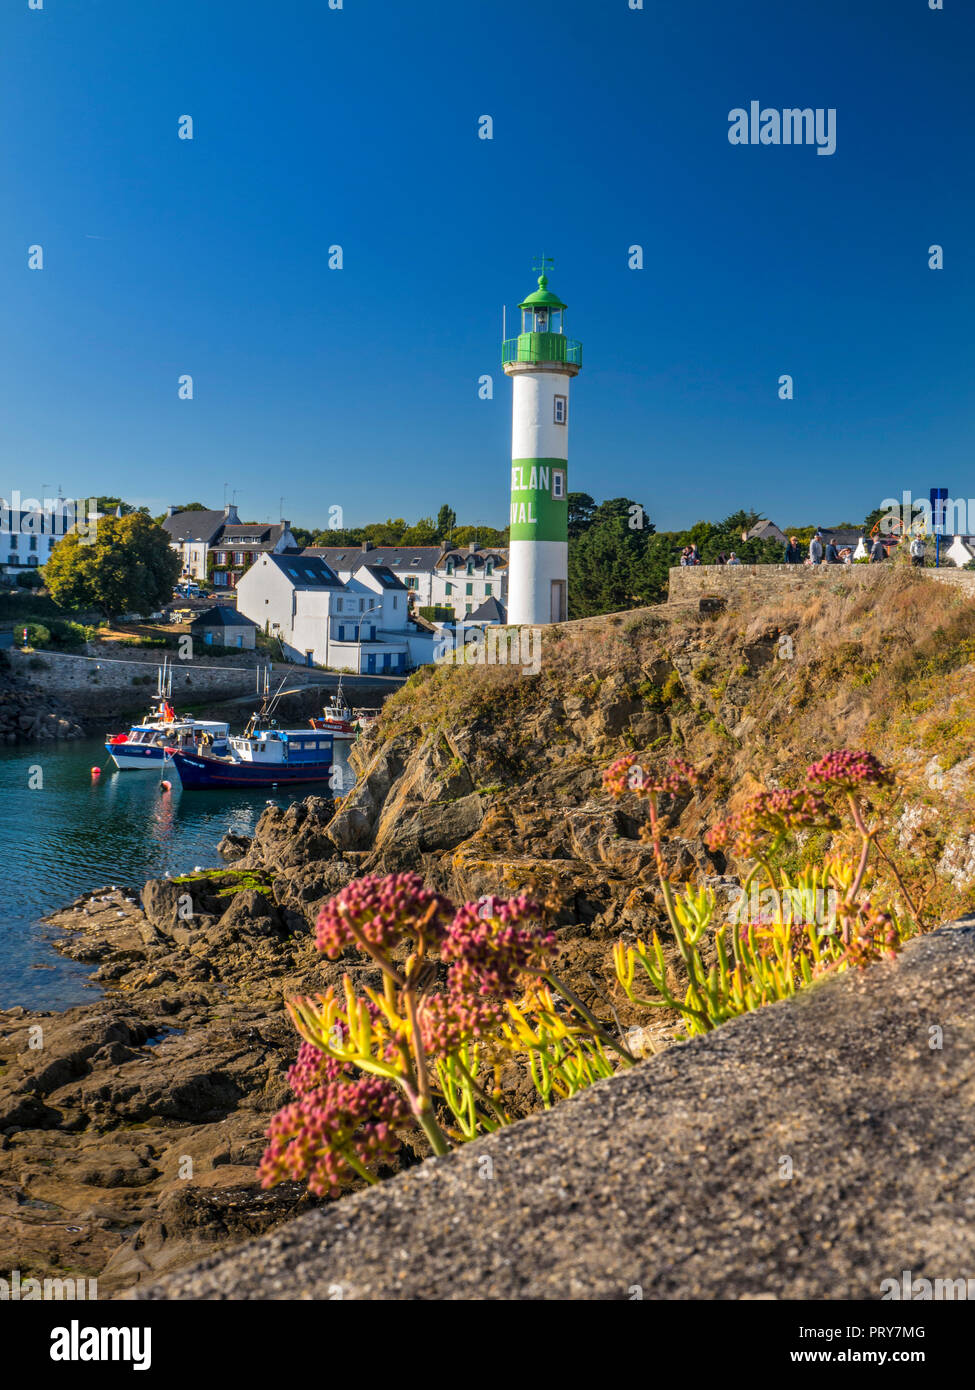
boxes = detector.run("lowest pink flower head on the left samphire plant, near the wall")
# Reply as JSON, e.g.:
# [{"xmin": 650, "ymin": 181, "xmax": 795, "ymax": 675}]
[{"xmin": 257, "ymin": 1067, "xmax": 409, "ymax": 1197}]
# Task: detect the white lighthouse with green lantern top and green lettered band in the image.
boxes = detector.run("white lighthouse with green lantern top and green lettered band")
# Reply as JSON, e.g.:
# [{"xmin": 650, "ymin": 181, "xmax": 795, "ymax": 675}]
[{"xmin": 502, "ymin": 256, "xmax": 583, "ymax": 626}]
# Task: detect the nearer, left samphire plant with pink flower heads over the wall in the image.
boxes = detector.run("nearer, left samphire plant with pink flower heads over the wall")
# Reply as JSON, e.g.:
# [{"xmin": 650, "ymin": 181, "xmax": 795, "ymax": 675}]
[{"xmin": 260, "ymin": 873, "xmax": 634, "ymax": 1195}]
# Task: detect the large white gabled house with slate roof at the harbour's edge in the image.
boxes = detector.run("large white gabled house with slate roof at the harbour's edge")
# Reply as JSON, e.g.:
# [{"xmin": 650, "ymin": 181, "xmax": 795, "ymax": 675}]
[{"xmin": 236, "ymin": 553, "xmax": 433, "ymax": 674}]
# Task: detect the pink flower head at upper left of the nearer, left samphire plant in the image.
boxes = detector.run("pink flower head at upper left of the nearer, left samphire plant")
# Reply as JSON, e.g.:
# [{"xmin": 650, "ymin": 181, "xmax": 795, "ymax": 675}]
[{"xmin": 316, "ymin": 873, "xmax": 453, "ymax": 960}]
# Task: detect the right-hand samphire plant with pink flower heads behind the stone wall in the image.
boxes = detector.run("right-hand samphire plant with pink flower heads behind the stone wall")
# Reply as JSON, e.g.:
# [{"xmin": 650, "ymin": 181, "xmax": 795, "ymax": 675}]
[{"xmin": 604, "ymin": 749, "xmax": 921, "ymax": 1034}]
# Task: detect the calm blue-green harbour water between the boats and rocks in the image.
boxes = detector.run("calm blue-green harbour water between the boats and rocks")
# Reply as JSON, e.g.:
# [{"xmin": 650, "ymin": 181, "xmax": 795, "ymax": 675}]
[{"xmin": 0, "ymin": 738, "xmax": 355, "ymax": 1009}]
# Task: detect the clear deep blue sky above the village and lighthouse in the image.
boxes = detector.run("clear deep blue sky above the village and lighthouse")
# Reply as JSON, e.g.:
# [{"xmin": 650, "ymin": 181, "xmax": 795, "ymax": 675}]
[{"xmin": 0, "ymin": 0, "xmax": 975, "ymax": 528}]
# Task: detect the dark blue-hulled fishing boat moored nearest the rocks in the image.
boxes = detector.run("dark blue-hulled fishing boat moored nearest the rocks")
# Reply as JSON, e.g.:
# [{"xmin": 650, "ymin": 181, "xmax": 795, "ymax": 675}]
[{"xmin": 172, "ymin": 682, "xmax": 332, "ymax": 790}]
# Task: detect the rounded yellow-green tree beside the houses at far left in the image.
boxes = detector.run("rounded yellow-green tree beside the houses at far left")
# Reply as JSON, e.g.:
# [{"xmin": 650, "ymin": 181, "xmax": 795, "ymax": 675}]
[{"xmin": 43, "ymin": 512, "xmax": 181, "ymax": 621}]
